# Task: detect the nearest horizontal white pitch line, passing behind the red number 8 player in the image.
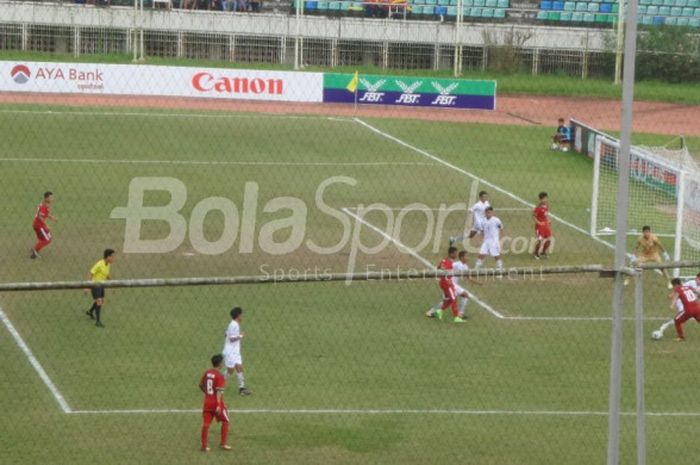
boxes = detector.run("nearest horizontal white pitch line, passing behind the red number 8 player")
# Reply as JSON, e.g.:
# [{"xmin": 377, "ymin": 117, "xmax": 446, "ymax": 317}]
[{"xmin": 71, "ymin": 408, "xmax": 700, "ymax": 418}]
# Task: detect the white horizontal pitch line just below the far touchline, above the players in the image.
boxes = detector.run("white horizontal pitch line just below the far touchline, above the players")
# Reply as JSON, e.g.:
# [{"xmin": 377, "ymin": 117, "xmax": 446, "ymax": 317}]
[{"xmin": 0, "ymin": 157, "xmax": 439, "ymax": 168}]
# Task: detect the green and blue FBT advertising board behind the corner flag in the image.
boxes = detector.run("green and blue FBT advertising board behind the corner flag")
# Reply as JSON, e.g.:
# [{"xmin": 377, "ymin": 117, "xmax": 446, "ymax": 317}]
[{"xmin": 323, "ymin": 73, "xmax": 496, "ymax": 110}]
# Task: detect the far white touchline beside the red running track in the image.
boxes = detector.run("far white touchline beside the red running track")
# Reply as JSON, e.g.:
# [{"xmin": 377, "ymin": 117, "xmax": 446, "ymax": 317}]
[{"xmin": 0, "ymin": 109, "xmax": 352, "ymax": 123}]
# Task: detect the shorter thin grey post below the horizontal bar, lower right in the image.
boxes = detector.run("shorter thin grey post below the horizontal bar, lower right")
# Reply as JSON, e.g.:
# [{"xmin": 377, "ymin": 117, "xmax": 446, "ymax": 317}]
[{"xmin": 634, "ymin": 272, "xmax": 647, "ymax": 465}]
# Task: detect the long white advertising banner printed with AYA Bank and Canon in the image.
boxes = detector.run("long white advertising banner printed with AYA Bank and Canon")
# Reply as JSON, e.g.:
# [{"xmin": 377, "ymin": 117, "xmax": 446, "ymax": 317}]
[{"xmin": 0, "ymin": 61, "xmax": 323, "ymax": 102}]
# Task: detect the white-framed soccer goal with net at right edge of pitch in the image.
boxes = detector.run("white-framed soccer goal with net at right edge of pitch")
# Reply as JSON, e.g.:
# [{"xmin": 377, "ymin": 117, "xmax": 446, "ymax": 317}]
[{"xmin": 590, "ymin": 136, "xmax": 700, "ymax": 270}]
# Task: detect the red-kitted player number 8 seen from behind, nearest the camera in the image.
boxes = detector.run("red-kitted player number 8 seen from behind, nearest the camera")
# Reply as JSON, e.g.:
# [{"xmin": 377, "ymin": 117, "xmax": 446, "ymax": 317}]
[{"xmin": 199, "ymin": 354, "xmax": 231, "ymax": 452}]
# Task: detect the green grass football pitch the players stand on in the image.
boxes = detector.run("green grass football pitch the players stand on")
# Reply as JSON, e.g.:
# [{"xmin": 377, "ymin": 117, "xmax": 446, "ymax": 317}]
[{"xmin": 0, "ymin": 106, "xmax": 700, "ymax": 465}]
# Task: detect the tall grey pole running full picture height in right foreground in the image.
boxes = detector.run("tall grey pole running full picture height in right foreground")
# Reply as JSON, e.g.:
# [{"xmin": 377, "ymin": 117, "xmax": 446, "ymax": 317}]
[{"xmin": 608, "ymin": 0, "xmax": 637, "ymax": 465}]
